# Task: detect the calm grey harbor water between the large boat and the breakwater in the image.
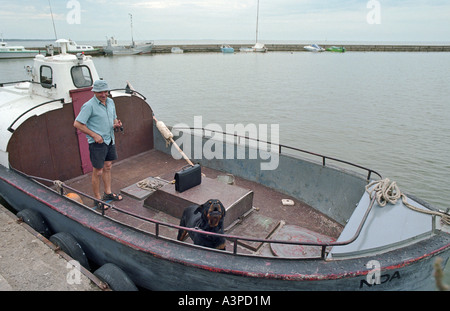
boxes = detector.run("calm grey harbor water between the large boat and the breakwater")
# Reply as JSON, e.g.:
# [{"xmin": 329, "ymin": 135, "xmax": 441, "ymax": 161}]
[{"xmin": 0, "ymin": 52, "xmax": 450, "ymax": 281}]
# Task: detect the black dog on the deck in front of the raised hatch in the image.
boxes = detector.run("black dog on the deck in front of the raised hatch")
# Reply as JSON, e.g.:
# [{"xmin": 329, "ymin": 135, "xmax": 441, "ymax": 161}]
[{"xmin": 177, "ymin": 199, "xmax": 225, "ymax": 250}]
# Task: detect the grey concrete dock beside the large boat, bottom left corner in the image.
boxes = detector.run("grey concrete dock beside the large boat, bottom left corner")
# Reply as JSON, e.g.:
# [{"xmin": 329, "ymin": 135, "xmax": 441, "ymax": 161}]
[{"xmin": 0, "ymin": 205, "xmax": 102, "ymax": 291}]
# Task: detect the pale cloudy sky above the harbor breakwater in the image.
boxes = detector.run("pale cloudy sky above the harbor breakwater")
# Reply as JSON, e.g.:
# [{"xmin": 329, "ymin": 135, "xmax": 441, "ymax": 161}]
[{"xmin": 0, "ymin": 0, "xmax": 450, "ymax": 43}]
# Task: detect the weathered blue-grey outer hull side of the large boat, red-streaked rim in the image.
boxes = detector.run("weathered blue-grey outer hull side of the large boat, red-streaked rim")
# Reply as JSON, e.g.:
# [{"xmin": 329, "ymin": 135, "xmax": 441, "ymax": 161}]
[{"xmin": 0, "ymin": 166, "xmax": 450, "ymax": 291}]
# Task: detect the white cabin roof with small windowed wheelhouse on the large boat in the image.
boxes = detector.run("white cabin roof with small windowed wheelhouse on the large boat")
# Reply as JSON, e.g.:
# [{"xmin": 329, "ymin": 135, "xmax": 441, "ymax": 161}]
[{"xmin": 0, "ymin": 40, "xmax": 99, "ymax": 167}]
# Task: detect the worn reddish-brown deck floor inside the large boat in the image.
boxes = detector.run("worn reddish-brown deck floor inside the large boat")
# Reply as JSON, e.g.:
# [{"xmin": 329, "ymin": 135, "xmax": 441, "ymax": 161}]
[{"xmin": 65, "ymin": 149, "xmax": 343, "ymax": 256}]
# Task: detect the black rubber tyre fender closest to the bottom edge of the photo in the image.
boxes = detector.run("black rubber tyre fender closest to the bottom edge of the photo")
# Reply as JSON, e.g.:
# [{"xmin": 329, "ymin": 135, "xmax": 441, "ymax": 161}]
[{"xmin": 94, "ymin": 263, "xmax": 138, "ymax": 291}]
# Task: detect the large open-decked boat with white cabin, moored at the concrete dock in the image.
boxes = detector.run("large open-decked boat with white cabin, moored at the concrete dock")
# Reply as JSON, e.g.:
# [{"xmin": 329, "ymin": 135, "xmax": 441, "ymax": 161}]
[{"xmin": 0, "ymin": 40, "xmax": 450, "ymax": 291}]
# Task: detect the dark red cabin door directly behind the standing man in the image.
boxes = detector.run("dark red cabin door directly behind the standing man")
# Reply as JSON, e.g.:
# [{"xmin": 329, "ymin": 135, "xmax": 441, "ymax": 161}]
[{"xmin": 70, "ymin": 87, "xmax": 94, "ymax": 174}]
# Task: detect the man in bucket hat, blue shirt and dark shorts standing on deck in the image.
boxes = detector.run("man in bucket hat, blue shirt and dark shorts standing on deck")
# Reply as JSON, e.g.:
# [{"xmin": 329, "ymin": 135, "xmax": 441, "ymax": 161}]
[{"xmin": 73, "ymin": 80, "xmax": 123, "ymax": 208}]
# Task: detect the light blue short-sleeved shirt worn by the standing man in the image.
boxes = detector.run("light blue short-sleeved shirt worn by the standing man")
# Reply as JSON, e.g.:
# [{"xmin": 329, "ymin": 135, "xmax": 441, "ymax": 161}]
[{"xmin": 76, "ymin": 96, "xmax": 117, "ymax": 145}]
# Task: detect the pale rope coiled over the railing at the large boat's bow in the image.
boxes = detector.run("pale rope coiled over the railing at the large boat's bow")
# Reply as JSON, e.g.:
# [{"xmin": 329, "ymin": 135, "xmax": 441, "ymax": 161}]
[{"xmin": 366, "ymin": 178, "xmax": 450, "ymax": 225}]
